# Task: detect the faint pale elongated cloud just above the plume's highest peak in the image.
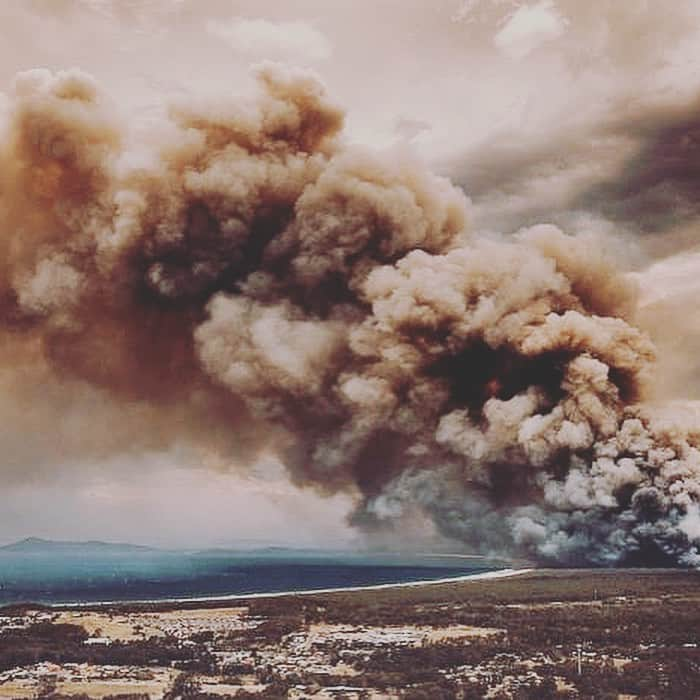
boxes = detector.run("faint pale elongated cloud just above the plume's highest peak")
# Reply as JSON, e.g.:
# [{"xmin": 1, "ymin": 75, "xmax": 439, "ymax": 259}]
[{"xmin": 206, "ymin": 17, "xmax": 333, "ymax": 62}]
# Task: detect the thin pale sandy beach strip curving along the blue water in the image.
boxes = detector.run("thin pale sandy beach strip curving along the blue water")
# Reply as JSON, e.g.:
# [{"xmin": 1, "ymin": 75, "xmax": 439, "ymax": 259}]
[{"xmin": 54, "ymin": 567, "xmax": 536, "ymax": 610}]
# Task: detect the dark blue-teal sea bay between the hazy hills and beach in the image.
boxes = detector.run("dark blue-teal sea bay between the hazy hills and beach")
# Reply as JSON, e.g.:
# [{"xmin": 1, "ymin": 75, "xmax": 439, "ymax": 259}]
[{"xmin": 0, "ymin": 543, "xmax": 505, "ymax": 604}]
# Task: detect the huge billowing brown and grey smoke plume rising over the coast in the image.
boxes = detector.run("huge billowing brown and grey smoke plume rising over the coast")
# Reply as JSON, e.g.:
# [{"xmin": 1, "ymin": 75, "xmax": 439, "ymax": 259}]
[{"xmin": 0, "ymin": 64, "xmax": 700, "ymax": 565}]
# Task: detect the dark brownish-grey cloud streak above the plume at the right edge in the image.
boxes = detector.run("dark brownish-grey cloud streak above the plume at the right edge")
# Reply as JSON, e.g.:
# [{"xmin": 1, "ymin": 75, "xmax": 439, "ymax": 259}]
[{"xmin": 445, "ymin": 95, "xmax": 700, "ymax": 246}]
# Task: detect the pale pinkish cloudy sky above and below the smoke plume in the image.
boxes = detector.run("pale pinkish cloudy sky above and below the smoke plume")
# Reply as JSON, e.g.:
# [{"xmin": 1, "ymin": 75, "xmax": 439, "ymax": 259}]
[{"xmin": 0, "ymin": 0, "xmax": 700, "ymax": 547}]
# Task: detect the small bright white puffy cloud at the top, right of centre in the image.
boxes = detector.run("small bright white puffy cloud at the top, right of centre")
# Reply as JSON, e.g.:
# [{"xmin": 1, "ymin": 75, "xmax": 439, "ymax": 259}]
[{"xmin": 494, "ymin": 0, "xmax": 567, "ymax": 59}]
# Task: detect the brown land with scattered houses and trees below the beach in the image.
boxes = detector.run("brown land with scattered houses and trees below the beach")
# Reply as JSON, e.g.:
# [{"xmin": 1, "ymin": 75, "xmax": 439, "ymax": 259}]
[{"xmin": 0, "ymin": 570, "xmax": 700, "ymax": 700}]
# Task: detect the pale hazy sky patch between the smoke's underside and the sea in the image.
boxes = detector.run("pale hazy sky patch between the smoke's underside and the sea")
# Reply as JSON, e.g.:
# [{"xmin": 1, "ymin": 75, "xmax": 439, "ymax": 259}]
[{"xmin": 0, "ymin": 454, "xmax": 357, "ymax": 547}]
